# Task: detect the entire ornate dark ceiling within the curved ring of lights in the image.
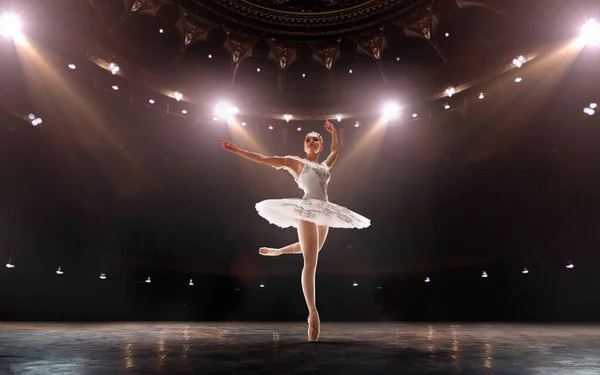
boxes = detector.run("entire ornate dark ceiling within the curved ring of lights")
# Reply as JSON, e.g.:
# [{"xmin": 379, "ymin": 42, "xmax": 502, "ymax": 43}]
[{"xmin": 76, "ymin": 0, "xmax": 554, "ymax": 118}]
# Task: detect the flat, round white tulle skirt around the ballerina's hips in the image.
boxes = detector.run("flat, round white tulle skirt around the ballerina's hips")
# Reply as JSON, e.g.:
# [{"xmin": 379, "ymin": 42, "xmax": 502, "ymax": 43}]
[{"xmin": 256, "ymin": 198, "xmax": 371, "ymax": 229}]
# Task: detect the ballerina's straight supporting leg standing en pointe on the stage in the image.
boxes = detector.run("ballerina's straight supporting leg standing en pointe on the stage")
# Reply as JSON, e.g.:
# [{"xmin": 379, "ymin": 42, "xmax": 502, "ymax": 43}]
[{"xmin": 298, "ymin": 220, "xmax": 320, "ymax": 341}]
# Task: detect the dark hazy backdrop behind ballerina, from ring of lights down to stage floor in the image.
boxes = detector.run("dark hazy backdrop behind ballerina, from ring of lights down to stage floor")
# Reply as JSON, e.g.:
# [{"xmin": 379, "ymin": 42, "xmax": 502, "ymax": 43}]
[{"xmin": 0, "ymin": 0, "xmax": 600, "ymax": 320}]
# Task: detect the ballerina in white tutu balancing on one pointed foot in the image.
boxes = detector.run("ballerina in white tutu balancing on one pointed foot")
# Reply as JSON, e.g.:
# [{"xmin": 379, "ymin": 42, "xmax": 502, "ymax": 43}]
[{"xmin": 220, "ymin": 118, "xmax": 371, "ymax": 342}]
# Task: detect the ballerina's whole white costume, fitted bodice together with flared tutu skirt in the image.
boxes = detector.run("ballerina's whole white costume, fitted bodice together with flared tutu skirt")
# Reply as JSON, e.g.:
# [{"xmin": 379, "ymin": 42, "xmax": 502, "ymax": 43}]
[{"xmin": 256, "ymin": 156, "xmax": 371, "ymax": 229}]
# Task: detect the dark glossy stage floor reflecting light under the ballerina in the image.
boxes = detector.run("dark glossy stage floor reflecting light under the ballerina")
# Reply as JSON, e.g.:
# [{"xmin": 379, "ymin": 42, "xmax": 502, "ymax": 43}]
[{"xmin": 0, "ymin": 322, "xmax": 600, "ymax": 375}]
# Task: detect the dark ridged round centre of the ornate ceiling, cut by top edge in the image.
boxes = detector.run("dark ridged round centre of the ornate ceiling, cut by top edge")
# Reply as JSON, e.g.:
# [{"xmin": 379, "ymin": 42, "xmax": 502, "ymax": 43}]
[{"xmin": 173, "ymin": 0, "xmax": 432, "ymax": 39}]
